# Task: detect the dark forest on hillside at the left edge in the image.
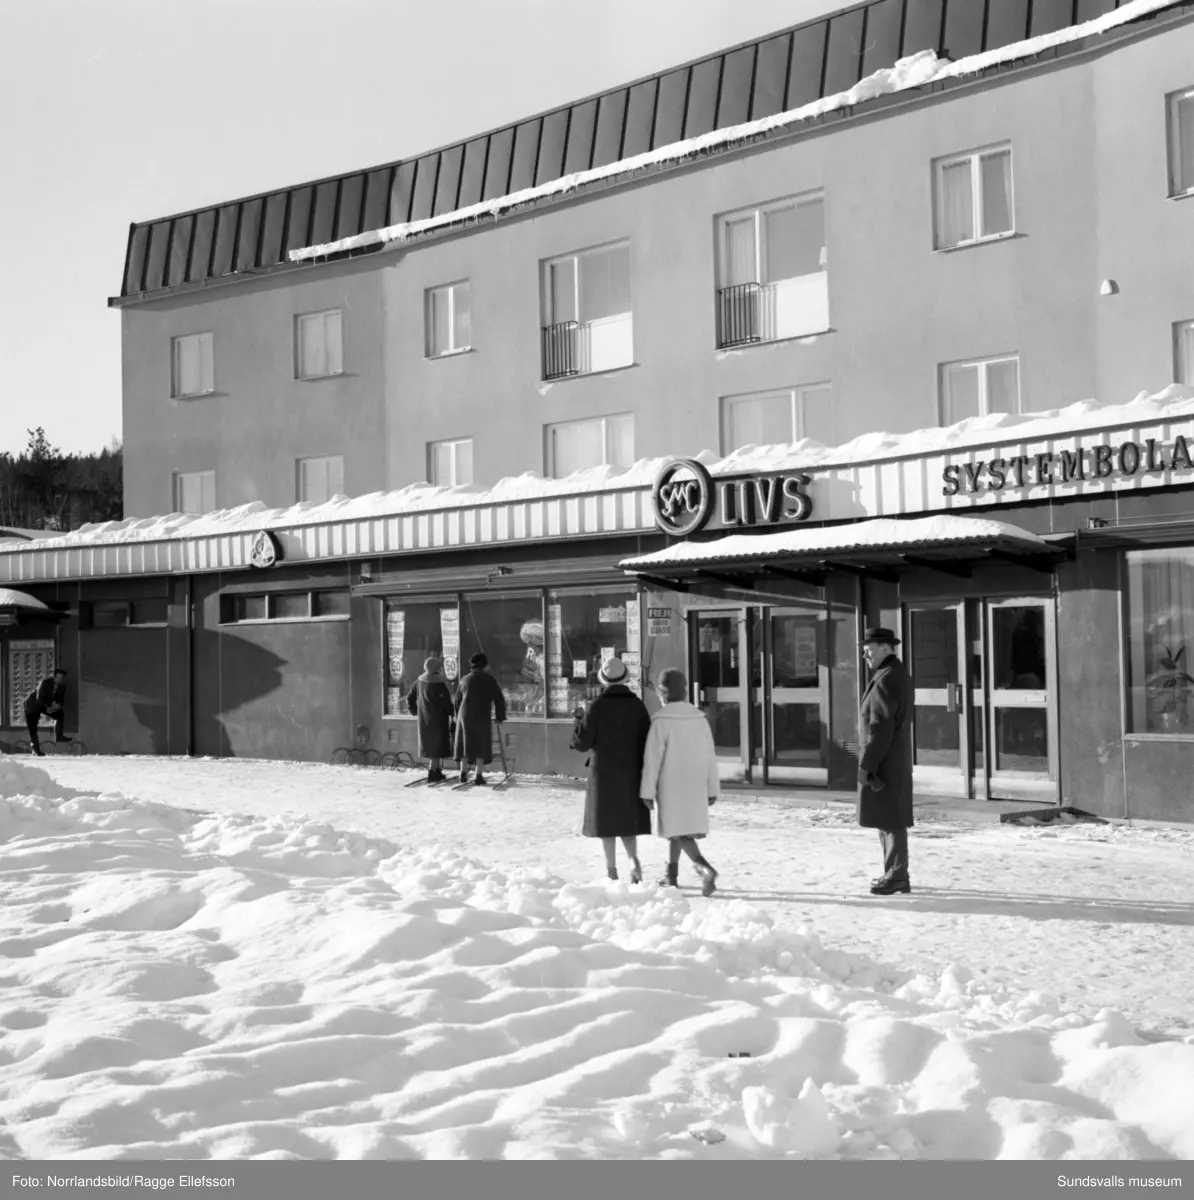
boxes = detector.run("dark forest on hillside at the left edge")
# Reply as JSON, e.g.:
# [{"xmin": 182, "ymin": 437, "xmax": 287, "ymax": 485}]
[{"xmin": 0, "ymin": 426, "xmax": 124, "ymax": 532}]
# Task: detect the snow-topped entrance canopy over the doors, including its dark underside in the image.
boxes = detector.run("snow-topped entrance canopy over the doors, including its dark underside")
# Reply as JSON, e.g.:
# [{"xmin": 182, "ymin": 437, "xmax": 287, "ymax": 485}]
[{"xmin": 619, "ymin": 514, "xmax": 1066, "ymax": 584}]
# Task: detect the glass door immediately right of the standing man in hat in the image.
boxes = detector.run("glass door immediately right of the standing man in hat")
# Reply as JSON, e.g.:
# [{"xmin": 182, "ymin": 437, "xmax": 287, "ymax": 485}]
[{"xmin": 906, "ymin": 604, "xmax": 970, "ymax": 796}]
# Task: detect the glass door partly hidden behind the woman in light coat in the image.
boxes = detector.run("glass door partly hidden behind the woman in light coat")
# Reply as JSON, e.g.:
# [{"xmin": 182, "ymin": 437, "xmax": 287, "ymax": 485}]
[{"xmin": 689, "ymin": 608, "xmax": 750, "ymax": 779}]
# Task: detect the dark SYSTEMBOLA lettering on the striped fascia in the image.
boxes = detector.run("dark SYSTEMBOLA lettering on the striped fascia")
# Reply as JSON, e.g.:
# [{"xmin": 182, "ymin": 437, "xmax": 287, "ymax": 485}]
[{"xmin": 941, "ymin": 436, "xmax": 1194, "ymax": 496}]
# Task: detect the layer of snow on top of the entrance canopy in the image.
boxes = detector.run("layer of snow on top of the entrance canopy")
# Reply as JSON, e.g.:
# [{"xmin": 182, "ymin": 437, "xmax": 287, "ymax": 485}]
[{"xmin": 618, "ymin": 512, "xmax": 1049, "ymax": 571}]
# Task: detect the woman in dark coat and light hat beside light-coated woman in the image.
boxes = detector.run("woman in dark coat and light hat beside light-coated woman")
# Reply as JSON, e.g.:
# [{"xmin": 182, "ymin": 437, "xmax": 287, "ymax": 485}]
[{"xmin": 572, "ymin": 659, "xmax": 650, "ymax": 883}]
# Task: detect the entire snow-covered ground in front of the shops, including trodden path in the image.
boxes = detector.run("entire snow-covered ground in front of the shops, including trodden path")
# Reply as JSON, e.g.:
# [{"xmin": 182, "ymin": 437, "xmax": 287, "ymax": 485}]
[{"xmin": 0, "ymin": 757, "xmax": 1194, "ymax": 1159}]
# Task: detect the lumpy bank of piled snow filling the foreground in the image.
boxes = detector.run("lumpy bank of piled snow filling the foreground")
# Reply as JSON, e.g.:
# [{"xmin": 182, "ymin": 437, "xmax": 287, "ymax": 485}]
[{"xmin": 0, "ymin": 794, "xmax": 1194, "ymax": 1159}]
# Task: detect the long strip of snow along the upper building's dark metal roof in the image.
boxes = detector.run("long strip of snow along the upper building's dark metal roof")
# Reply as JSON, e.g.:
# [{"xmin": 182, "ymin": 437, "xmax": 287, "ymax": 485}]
[{"xmin": 289, "ymin": 0, "xmax": 1177, "ymax": 262}]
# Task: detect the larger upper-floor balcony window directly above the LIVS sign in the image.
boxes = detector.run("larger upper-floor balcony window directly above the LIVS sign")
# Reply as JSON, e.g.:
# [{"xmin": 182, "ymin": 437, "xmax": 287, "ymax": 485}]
[{"xmin": 718, "ymin": 193, "xmax": 829, "ymax": 347}]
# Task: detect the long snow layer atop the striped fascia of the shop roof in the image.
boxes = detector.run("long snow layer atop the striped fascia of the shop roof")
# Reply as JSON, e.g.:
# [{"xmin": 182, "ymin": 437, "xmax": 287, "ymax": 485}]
[{"xmin": 0, "ymin": 384, "xmax": 1194, "ymax": 554}]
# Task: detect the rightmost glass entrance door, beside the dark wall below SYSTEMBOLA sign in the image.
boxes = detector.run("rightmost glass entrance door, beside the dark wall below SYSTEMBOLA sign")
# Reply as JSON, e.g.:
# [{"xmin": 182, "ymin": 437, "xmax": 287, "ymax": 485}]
[{"xmin": 985, "ymin": 598, "xmax": 1058, "ymax": 803}]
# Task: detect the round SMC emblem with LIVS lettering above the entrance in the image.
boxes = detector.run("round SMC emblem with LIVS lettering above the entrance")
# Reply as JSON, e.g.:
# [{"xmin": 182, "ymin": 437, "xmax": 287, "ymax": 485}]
[{"xmin": 652, "ymin": 458, "xmax": 812, "ymax": 538}]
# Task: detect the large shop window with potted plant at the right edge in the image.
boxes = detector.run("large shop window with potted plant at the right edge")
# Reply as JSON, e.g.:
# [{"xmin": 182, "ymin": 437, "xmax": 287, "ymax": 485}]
[{"xmin": 1127, "ymin": 546, "xmax": 1194, "ymax": 736}]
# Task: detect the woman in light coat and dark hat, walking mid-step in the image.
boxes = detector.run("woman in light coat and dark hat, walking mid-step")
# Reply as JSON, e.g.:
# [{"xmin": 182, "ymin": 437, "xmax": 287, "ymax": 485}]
[{"xmin": 638, "ymin": 670, "xmax": 721, "ymax": 896}]
